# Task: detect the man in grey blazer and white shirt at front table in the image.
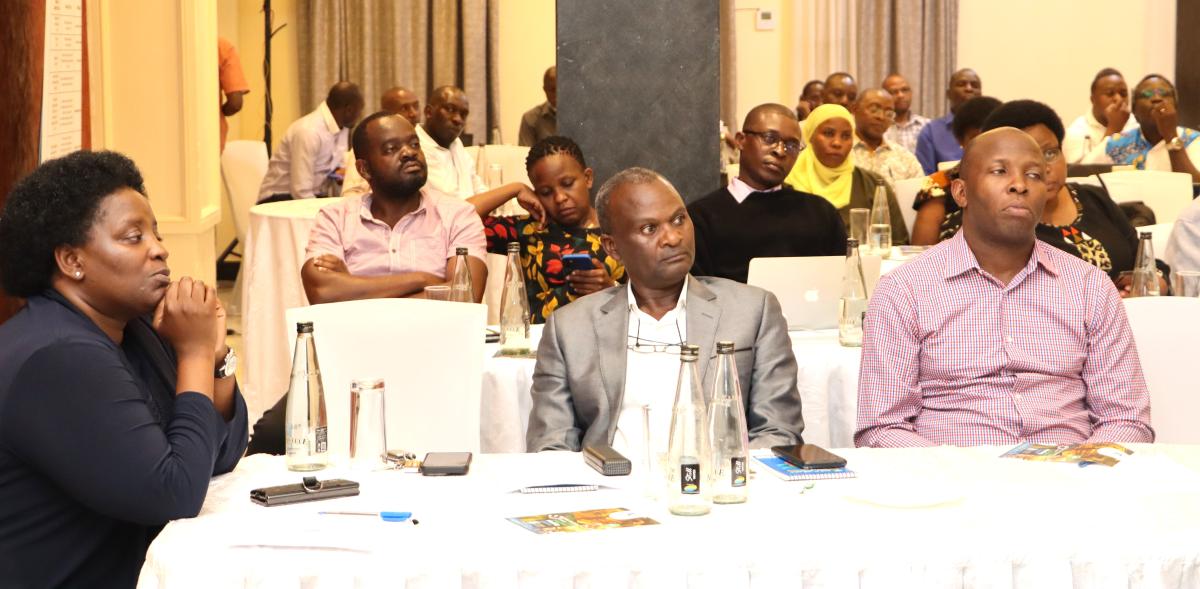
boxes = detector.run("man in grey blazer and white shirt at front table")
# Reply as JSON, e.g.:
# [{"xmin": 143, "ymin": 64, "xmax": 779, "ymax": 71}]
[{"xmin": 526, "ymin": 168, "xmax": 804, "ymax": 458}]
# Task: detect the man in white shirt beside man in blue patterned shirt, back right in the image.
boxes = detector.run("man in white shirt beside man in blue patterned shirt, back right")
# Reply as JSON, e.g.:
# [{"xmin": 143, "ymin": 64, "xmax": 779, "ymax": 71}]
[{"xmin": 1062, "ymin": 67, "xmax": 1138, "ymax": 163}]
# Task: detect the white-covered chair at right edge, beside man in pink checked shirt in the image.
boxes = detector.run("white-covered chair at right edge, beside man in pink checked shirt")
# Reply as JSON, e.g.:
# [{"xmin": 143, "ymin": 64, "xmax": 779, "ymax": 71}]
[{"xmin": 1124, "ymin": 296, "xmax": 1200, "ymax": 444}]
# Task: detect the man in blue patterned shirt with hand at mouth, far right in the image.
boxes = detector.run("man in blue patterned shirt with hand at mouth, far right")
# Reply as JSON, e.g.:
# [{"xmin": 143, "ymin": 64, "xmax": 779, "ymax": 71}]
[{"xmin": 1084, "ymin": 73, "xmax": 1200, "ymax": 182}]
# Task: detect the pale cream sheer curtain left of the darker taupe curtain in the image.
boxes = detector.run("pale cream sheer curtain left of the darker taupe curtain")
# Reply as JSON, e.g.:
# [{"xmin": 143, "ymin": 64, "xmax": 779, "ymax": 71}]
[{"xmin": 785, "ymin": 0, "xmax": 863, "ymax": 100}]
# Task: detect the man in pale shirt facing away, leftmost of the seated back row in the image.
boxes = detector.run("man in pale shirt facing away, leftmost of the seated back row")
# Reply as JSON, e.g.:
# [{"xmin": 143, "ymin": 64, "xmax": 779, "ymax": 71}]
[{"xmin": 258, "ymin": 82, "xmax": 364, "ymax": 203}]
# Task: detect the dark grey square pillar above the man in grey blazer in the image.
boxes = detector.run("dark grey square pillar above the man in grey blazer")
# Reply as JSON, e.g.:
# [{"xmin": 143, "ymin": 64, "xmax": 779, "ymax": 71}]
[{"xmin": 558, "ymin": 0, "xmax": 720, "ymax": 202}]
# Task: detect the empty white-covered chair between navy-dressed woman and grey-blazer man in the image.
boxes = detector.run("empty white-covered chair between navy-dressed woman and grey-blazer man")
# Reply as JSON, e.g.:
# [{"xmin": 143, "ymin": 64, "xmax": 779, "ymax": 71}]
[{"xmin": 280, "ymin": 299, "xmax": 486, "ymax": 457}]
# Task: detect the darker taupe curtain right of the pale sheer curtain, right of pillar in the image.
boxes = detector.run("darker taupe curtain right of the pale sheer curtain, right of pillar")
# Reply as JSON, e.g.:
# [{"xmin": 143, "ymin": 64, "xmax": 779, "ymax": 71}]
[{"xmin": 853, "ymin": 0, "xmax": 955, "ymax": 118}]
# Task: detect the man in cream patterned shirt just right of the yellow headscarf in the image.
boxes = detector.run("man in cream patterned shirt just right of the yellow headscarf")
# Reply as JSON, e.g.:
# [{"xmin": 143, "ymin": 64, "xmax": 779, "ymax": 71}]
[{"xmin": 850, "ymin": 88, "xmax": 925, "ymax": 190}]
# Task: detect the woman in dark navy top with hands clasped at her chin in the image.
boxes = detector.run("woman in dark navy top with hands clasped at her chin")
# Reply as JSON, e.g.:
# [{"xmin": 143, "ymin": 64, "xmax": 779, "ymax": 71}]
[{"xmin": 0, "ymin": 151, "xmax": 246, "ymax": 588}]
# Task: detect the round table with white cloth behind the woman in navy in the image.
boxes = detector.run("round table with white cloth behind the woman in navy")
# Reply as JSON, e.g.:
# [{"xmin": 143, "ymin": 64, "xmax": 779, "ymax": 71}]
[{"xmin": 239, "ymin": 198, "xmax": 341, "ymax": 423}]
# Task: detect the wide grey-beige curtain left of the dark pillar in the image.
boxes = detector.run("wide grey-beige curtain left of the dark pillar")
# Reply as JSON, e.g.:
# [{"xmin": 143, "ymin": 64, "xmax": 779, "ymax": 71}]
[{"xmin": 296, "ymin": 0, "xmax": 499, "ymax": 144}]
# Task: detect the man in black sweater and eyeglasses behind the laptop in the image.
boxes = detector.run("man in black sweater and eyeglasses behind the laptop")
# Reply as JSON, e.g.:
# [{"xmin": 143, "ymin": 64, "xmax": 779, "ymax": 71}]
[{"xmin": 688, "ymin": 104, "xmax": 846, "ymax": 282}]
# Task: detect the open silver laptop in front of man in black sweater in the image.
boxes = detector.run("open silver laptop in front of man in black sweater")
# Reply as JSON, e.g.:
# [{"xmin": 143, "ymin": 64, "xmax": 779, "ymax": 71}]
[{"xmin": 746, "ymin": 256, "xmax": 881, "ymax": 330}]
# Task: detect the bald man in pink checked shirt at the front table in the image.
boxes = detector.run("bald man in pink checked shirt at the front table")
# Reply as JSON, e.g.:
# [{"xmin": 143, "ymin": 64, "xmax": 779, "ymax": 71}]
[{"xmin": 854, "ymin": 127, "xmax": 1154, "ymax": 446}]
